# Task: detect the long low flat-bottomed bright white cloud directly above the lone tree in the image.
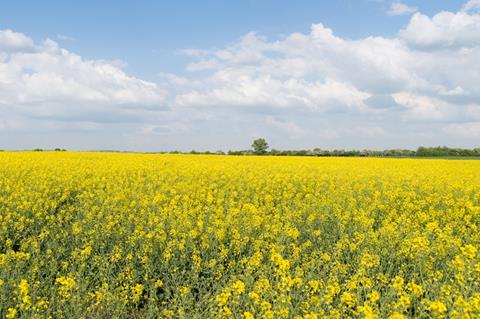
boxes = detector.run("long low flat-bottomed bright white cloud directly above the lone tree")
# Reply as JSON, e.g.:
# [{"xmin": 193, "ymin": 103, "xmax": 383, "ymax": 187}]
[{"xmin": 176, "ymin": 74, "xmax": 369, "ymax": 110}]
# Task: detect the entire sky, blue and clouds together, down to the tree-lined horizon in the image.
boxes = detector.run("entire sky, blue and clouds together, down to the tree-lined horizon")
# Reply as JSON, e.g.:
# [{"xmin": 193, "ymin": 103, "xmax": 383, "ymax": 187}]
[{"xmin": 0, "ymin": 0, "xmax": 480, "ymax": 151}]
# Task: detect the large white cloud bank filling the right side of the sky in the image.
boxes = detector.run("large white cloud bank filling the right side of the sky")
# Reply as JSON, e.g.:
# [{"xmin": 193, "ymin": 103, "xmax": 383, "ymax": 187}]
[{"xmin": 176, "ymin": 12, "xmax": 480, "ymax": 121}]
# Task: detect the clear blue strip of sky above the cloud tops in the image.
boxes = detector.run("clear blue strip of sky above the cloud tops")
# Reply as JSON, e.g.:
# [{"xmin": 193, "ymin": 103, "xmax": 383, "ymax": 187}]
[{"xmin": 0, "ymin": 0, "xmax": 464, "ymax": 80}]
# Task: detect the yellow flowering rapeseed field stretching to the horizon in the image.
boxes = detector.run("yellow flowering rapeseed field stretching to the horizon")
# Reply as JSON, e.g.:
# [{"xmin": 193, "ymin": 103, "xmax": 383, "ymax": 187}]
[{"xmin": 0, "ymin": 152, "xmax": 480, "ymax": 319}]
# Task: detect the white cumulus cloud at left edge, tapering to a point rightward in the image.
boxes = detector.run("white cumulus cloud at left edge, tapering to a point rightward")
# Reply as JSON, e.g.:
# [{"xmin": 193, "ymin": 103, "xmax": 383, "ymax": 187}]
[{"xmin": 0, "ymin": 30, "xmax": 166, "ymax": 129}]
